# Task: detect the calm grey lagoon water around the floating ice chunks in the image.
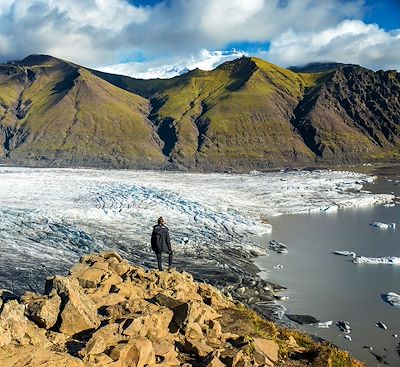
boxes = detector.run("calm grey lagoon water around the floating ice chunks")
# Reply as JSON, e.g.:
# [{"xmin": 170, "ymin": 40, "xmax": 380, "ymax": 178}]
[{"xmin": 256, "ymin": 170, "xmax": 400, "ymax": 366}]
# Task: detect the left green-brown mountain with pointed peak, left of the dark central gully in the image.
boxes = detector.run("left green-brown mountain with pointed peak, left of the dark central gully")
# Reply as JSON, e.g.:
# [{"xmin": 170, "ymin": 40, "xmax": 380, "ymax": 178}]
[{"xmin": 0, "ymin": 56, "xmax": 165, "ymax": 167}]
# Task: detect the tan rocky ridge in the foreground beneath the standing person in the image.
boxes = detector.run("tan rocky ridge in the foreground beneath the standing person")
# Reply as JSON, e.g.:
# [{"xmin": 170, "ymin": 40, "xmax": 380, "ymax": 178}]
[{"xmin": 0, "ymin": 253, "xmax": 361, "ymax": 367}]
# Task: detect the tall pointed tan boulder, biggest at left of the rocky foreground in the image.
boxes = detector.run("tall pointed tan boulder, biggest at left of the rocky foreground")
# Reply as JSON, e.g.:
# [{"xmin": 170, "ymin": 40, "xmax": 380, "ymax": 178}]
[{"xmin": 46, "ymin": 276, "xmax": 100, "ymax": 335}]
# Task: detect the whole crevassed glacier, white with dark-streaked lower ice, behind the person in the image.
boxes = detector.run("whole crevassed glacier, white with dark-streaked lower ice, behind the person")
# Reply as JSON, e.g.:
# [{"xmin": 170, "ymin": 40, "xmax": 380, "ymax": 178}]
[{"xmin": 0, "ymin": 167, "xmax": 394, "ymax": 291}]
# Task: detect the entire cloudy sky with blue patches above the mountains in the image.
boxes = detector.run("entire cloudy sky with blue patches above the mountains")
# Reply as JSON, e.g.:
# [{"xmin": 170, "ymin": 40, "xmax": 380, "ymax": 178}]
[{"xmin": 0, "ymin": 0, "xmax": 400, "ymax": 78}]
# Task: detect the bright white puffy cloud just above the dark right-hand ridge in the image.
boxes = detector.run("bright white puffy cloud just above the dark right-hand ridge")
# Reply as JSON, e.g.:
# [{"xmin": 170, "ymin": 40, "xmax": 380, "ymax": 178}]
[{"xmin": 259, "ymin": 20, "xmax": 400, "ymax": 70}]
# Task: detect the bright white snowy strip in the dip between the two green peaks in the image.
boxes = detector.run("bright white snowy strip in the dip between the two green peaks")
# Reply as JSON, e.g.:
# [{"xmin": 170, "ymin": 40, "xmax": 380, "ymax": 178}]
[{"xmin": 99, "ymin": 49, "xmax": 244, "ymax": 79}]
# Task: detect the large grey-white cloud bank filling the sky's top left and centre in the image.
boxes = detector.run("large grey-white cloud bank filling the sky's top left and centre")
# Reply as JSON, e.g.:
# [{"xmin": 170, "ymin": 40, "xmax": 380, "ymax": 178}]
[{"xmin": 0, "ymin": 0, "xmax": 363, "ymax": 67}]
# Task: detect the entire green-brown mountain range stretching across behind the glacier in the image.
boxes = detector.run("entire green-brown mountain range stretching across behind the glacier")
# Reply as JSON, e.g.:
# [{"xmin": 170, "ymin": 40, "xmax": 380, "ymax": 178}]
[{"xmin": 0, "ymin": 55, "xmax": 400, "ymax": 171}]
